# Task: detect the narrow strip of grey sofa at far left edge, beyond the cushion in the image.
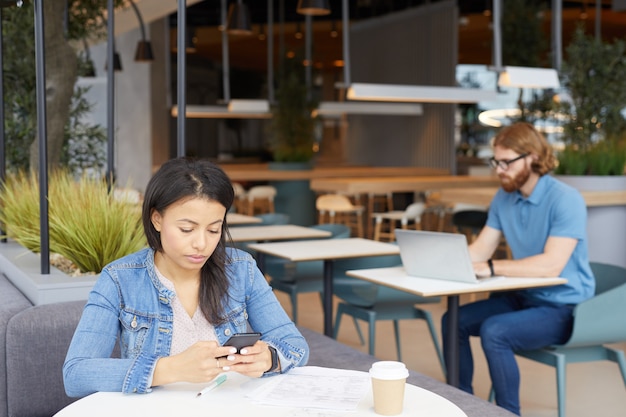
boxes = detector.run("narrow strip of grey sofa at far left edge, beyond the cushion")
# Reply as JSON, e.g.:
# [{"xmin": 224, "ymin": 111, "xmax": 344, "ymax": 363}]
[{"xmin": 0, "ymin": 274, "xmax": 32, "ymax": 417}]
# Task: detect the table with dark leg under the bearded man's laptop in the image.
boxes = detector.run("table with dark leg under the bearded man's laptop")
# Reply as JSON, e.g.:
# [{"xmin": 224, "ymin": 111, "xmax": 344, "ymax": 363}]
[{"xmin": 346, "ymin": 267, "xmax": 567, "ymax": 387}]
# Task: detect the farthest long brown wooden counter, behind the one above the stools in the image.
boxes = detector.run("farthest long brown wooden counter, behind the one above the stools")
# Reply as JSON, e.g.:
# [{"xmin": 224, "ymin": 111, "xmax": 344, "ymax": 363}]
[{"xmin": 220, "ymin": 164, "xmax": 448, "ymax": 181}]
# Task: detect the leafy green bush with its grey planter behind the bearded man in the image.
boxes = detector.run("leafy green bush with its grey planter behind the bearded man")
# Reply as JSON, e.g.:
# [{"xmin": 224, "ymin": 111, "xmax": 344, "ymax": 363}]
[{"xmin": 544, "ymin": 27, "xmax": 626, "ymax": 266}]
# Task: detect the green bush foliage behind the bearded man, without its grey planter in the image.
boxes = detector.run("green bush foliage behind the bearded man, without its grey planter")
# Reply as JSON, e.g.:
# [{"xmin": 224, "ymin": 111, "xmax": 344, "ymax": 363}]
[{"xmin": 556, "ymin": 27, "xmax": 626, "ymax": 175}]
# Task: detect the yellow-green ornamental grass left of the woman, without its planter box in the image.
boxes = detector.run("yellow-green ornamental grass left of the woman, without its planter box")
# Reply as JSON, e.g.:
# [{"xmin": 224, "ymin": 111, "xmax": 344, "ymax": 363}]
[{"xmin": 0, "ymin": 170, "xmax": 146, "ymax": 273}]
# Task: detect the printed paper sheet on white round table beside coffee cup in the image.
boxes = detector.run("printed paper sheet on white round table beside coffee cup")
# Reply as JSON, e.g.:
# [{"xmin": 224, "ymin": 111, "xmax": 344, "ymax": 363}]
[{"xmin": 248, "ymin": 366, "xmax": 370, "ymax": 411}]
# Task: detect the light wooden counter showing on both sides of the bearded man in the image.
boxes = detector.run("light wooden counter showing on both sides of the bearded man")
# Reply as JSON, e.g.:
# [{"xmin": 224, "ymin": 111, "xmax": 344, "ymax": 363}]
[{"xmin": 440, "ymin": 187, "xmax": 626, "ymax": 207}]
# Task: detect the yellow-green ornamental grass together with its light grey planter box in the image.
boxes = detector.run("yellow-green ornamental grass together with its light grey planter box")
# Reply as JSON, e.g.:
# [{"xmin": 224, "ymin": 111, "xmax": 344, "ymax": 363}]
[{"xmin": 0, "ymin": 169, "xmax": 146, "ymax": 304}]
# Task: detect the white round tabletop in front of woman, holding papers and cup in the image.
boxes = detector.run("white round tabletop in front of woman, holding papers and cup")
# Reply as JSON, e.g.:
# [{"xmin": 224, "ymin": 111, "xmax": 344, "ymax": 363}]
[{"xmin": 55, "ymin": 369, "xmax": 467, "ymax": 417}]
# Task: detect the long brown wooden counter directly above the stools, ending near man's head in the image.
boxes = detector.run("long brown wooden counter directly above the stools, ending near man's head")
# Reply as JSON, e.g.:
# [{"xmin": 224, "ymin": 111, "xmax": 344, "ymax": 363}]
[{"xmin": 311, "ymin": 174, "xmax": 499, "ymax": 194}]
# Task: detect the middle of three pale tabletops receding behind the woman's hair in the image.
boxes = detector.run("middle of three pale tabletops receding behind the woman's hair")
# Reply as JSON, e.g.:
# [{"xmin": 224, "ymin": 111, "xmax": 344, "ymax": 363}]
[{"xmin": 229, "ymin": 224, "xmax": 332, "ymax": 242}]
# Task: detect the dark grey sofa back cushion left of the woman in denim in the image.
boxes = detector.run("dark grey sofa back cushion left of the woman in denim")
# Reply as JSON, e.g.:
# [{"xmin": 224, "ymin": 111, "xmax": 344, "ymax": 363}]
[{"xmin": 6, "ymin": 301, "xmax": 85, "ymax": 417}]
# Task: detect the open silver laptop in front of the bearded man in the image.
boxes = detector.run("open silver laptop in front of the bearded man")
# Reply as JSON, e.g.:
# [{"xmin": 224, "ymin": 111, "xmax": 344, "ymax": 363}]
[{"xmin": 395, "ymin": 229, "xmax": 501, "ymax": 283}]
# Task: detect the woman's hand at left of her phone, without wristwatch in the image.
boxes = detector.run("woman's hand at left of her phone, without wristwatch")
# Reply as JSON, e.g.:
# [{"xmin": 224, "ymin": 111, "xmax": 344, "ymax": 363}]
[{"xmin": 152, "ymin": 341, "xmax": 235, "ymax": 386}]
